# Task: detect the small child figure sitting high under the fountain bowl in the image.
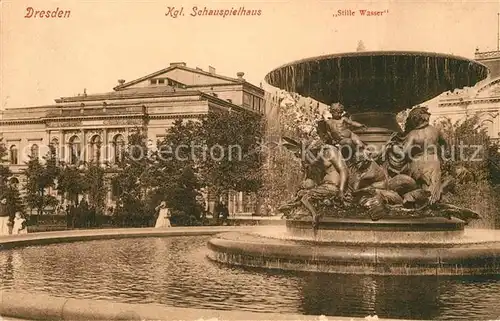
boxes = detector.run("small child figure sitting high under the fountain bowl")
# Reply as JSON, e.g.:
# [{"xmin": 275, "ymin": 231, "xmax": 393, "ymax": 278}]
[{"xmin": 325, "ymin": 103, "xmax": 366, "ymax": 149}]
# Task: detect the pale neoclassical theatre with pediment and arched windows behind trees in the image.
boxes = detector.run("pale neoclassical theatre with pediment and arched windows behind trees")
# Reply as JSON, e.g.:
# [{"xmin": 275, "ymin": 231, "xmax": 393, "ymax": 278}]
[{"xmin": 0, "ymin": 62, "xmax": 267, "ymax": 213}]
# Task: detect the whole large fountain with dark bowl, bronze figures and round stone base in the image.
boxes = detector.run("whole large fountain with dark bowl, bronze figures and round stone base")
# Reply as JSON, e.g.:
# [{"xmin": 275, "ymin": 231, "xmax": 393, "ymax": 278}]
[{"xmin": 208, "ymin": 52, "xmax": 500, "ymax": 275}]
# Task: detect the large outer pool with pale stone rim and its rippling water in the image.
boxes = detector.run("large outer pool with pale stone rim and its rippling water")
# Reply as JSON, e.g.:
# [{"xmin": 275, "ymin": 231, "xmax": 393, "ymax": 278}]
[{"xmin": 0, "ymin": 227, "xmax": 500, "ymax": 320}]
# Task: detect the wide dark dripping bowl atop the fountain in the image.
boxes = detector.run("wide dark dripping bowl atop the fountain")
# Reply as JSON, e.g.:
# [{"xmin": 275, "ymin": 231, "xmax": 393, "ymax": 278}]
[{"xmin": 265, "ymin": 51, "xmax": 488, "ymax": 114}]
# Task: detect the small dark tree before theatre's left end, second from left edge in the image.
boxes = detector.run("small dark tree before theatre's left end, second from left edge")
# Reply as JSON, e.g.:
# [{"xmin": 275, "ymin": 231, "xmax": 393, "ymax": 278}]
[{"xmin": 24, "ymin": 146, "xmax": 59, "ymax": 215}]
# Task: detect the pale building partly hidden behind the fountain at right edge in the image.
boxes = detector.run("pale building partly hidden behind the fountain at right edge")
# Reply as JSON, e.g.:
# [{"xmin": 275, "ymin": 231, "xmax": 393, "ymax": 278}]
[{"xmin": 427, "ymin": 49, "xmax": 500, "ymax": 140}]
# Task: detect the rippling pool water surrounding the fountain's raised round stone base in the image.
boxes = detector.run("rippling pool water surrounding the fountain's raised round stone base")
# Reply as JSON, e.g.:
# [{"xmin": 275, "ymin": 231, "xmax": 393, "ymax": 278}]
[{"xmin": 0, "ymin": 236, "xmax": 500, "ymax": 320}]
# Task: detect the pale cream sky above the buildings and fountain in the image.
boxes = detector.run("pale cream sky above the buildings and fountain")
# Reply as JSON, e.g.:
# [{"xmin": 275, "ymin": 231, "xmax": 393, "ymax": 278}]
[{"xmin": 0, "ymin": 0, "xmax": 500, "ymax": 109}]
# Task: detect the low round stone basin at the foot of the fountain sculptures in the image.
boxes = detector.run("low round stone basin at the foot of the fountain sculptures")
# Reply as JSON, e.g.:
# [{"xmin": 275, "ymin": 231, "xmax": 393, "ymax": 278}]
[{"xmin": 208, "ymin": 220, "xmax": 500, "ymax": 275}]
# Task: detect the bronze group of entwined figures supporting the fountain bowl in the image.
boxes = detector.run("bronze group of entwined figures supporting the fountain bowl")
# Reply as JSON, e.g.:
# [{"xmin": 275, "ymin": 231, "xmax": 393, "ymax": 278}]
[{"xmin": 280, "ymin": 107, "xmax": 479, "ymax": 227}]
